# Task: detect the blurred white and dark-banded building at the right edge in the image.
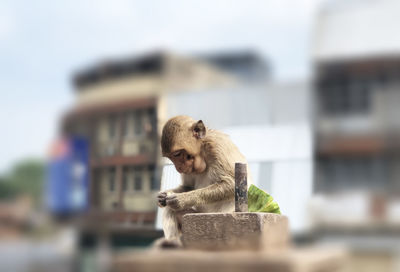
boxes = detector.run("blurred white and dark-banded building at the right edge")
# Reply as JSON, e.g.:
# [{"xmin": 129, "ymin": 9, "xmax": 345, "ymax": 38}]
[{"xmin": 311, "ymin": 0, "xmax": 400, "ymax": 271}]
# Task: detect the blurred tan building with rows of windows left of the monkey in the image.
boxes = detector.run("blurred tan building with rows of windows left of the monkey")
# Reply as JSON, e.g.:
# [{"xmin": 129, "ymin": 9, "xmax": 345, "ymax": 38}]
[{"xmin": 63, "ymin": 50, "xmax": 234, "ymax": 228}]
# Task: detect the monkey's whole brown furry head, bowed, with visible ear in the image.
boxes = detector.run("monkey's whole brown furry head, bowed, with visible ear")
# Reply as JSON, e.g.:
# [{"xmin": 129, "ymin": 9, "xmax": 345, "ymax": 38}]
[{"xmin": 161, "ymin": 115, "xmax": 206, "ymax": 174}]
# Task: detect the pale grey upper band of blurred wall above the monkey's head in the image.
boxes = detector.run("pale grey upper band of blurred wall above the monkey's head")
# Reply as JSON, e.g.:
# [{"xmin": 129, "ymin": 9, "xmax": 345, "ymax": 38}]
[{"xmin": 159, "ymin": 81, "xmax": 311, "ymax": 129}]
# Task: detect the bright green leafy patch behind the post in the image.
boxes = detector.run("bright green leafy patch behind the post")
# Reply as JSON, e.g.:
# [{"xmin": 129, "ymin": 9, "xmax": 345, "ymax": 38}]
[{"xmin": 247, "ymin": 185, "xmax": 281, "ymax": 214}]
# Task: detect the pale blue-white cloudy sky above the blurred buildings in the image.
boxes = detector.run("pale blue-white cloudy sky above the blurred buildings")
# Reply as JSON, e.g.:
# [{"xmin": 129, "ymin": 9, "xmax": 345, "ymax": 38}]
[{"xmin": 0, "ymin": 0, "xmax": 320, "ymax": 172}]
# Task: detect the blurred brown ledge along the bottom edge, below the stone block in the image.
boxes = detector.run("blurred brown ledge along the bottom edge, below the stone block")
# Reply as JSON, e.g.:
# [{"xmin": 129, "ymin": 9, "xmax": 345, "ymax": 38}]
[{"xmin": 113, "ymin": 248, "xmax": 347, "ymax": 272}]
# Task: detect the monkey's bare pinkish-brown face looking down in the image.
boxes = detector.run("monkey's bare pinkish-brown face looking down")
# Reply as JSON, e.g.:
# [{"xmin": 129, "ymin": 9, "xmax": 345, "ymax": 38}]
[{"xmin": 168, "ymin": 149, "xmax": 206, "ymax": 174}]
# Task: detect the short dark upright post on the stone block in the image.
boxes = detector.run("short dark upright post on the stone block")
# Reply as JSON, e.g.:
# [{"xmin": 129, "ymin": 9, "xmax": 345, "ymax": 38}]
[{"xmin": 235, "ymin": 162, "xmax": 248, "ymax": 212}]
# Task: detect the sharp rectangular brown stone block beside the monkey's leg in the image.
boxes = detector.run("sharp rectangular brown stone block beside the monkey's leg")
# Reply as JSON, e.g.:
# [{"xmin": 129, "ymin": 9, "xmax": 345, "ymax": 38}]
[{"xmin": 182, "ymin": 212, "xmax": 289, "ymax": 251}]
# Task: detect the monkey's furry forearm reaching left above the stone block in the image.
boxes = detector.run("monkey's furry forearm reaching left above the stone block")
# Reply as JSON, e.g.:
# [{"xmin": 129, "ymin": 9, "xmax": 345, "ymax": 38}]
[{"xmin": 166, "ymin": 180, "xmax": 235, "ymax": 210}]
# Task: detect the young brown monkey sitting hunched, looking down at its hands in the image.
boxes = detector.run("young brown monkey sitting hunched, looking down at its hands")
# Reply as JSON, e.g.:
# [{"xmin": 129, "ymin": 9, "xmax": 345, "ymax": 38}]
[{"xmin": 157, "ymin": 115, "xmax": 252, "ymax": 247}]
